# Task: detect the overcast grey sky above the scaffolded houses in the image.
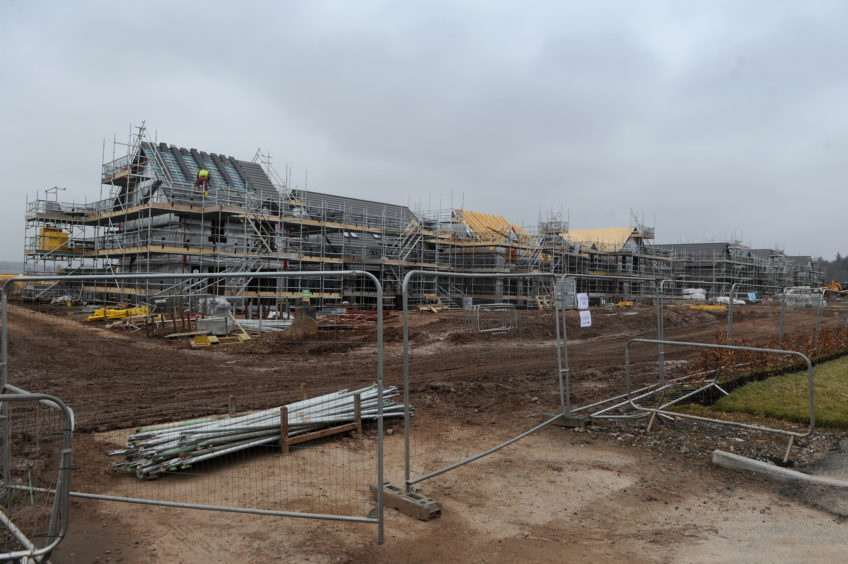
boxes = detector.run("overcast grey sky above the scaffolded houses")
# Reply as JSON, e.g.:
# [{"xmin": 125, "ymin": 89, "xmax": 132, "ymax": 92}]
[{"xmin": 0, "ymin": 0, "xmax": 848, "ymax": 260}]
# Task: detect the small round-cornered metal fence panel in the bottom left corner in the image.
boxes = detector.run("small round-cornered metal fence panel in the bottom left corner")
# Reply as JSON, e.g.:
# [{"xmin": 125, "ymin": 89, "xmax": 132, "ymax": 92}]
[{"xmin": 0, "ymin": 386, "xmax": 73, "ymax": 562}]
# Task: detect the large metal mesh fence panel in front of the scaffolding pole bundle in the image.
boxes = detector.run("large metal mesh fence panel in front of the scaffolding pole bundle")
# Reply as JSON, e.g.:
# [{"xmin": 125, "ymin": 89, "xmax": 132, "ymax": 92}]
[{"xmin": 3, "ymin": 271, "xmax": 386, "ymax": 542}]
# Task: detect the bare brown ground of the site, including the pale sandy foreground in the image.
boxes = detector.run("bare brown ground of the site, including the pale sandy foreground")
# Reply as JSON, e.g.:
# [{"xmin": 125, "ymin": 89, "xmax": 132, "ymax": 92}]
[{"xmin": 9, "ymin": 305, "xmax": 848, "ymax": 563}]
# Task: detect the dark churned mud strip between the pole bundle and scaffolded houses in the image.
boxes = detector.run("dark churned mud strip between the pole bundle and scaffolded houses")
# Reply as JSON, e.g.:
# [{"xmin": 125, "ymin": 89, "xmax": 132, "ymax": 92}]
[{"xmin": 9, "ymin": 305, "xmax": 845, "ymax": 431}]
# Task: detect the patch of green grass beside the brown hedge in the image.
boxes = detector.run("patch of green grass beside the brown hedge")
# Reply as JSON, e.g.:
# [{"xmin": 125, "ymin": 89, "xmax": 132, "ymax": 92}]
[{"xmin": 711, "ymin": 356, "xmax": 848, "ymax": 429}]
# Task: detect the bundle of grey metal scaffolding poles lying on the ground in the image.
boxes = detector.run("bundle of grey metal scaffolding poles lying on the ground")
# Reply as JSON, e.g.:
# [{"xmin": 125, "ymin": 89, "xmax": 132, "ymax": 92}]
[{"xmin": 109, "ymin": 385, "xmax": 403, "ymax": 478}]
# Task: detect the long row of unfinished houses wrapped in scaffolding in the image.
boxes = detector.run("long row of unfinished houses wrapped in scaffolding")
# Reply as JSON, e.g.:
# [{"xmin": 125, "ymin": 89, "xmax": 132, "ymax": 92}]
[{"xmin": 25, "ymin": 127, "xmax": 823, "ymax": 307}]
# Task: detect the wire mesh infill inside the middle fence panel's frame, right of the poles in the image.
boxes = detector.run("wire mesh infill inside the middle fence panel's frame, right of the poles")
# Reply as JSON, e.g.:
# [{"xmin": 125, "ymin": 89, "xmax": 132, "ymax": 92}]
[{"xmin": 406, "ymin": 274, "xmax": 561, "ymax": 490}]
